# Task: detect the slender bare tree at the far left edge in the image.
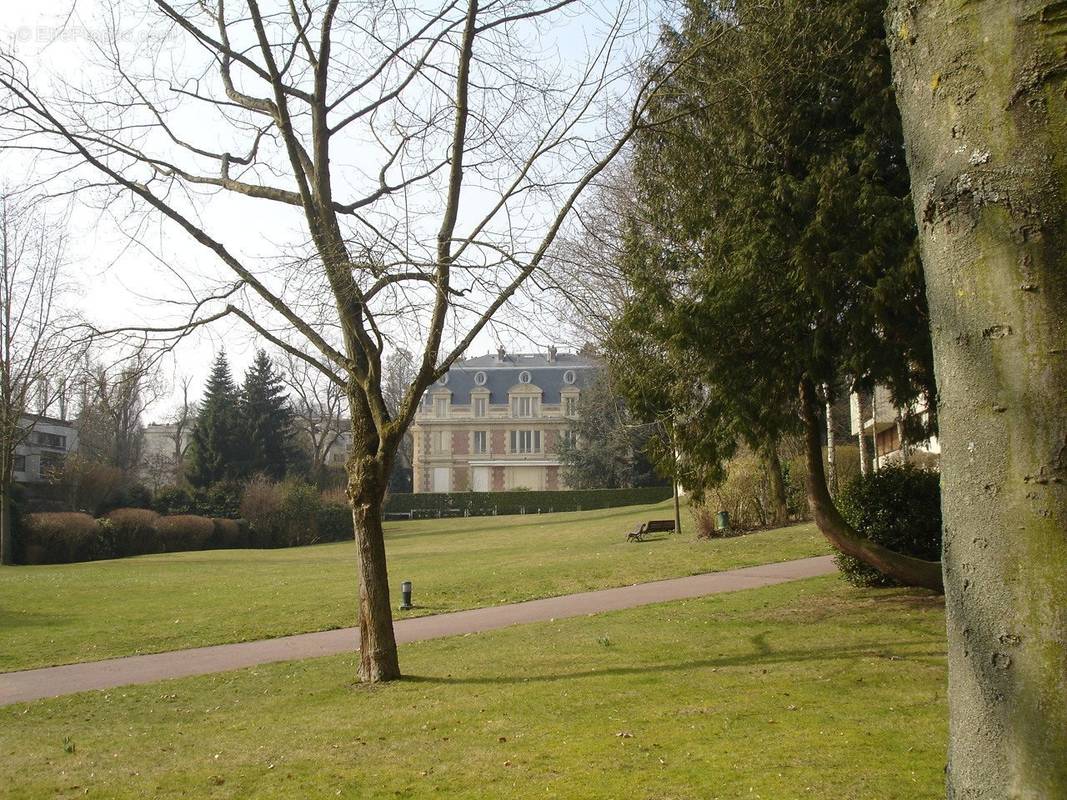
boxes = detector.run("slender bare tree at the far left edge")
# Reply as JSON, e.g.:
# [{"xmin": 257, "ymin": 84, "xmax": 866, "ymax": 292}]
[{"xmin": 0, "ymin": 192, "xmax": 78, "ymax": 564}]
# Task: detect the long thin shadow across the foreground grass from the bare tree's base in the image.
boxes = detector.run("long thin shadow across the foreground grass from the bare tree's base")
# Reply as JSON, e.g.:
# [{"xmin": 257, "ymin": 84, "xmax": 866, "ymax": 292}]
[{"xmin": 390, "ymin": 634, "xmax": 944, "ymax": 686}]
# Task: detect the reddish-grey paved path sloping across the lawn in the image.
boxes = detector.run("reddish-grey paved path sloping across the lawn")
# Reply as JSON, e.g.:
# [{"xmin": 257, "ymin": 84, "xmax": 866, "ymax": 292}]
[{"xmin": 0, "ymin": 556, "xmax": 834, "ymax": 705}]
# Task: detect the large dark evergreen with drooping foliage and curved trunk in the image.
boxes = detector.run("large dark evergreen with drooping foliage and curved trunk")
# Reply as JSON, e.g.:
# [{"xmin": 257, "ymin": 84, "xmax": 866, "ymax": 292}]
[{"xmin": 617, "ymin": 0, "xmax": 940, "ymax": 588}]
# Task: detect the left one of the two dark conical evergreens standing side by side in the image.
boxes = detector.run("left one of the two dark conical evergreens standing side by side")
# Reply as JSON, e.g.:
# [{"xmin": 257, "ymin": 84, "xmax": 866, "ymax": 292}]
[{"xmin": 187, "ymin": 352, "xmax": 244, "ymax": 486}]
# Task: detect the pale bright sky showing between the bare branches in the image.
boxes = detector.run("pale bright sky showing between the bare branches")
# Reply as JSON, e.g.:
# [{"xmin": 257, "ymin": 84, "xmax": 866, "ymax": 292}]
[{"xmin": 0, "ymin": 0, "xmax": 657, "ymax": 420}]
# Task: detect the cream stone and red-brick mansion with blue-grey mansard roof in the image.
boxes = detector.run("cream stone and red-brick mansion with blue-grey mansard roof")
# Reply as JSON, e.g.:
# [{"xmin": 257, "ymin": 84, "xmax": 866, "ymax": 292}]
[{"xmin": 412, "ymin": 348, "xmax": 600, "ymax": 492}]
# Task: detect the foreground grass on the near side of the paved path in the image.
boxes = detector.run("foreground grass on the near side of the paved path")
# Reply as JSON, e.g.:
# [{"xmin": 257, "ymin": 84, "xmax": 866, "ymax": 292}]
[{"xmin": 0, "ymin": 578, "xmax": 946, "ymax": 800}]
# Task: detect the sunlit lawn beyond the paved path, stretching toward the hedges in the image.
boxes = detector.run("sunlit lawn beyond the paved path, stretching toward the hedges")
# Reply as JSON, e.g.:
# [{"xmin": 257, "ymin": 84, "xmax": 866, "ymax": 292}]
[{"xmin": 0, "ymin": 503, "xmax": 828, "ymax": 671}]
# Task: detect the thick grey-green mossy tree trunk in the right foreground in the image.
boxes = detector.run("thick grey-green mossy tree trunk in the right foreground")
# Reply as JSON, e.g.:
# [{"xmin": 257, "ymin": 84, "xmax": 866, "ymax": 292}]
[{"xmin": 887, "ymin": 0, "xmax": 1067, "ymax": 800}]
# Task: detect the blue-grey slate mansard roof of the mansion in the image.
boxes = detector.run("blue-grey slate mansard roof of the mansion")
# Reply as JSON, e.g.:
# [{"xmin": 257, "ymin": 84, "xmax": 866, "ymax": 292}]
[{"xmin": 424, "ymin": 353, "xmax": 601, "ymax": 405}]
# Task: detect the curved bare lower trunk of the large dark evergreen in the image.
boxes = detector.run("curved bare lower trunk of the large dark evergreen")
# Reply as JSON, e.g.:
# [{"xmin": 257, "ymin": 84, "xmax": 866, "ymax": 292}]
[{"xmin": 800, "ymin": 379, "xmax": 943, "ymax": 592}]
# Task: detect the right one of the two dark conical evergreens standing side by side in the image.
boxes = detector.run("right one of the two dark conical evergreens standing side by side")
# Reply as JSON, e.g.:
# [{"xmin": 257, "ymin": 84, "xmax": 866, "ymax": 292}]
[{"xmin": 238, "ymin": 350, "xmax": 297, "ymax": 480}]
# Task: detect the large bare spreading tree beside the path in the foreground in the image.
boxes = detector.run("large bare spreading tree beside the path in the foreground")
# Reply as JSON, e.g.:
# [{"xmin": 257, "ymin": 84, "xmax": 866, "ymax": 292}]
[{"xmin": 0, "ymin": 0, "xmax": 682, "ymax": 682}]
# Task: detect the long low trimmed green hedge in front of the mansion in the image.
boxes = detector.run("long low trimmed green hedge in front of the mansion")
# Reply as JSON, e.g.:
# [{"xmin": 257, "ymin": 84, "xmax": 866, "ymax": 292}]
[{"xmin": 384, "ymin": 486, "xmax": 672, "ymax": 518}]
